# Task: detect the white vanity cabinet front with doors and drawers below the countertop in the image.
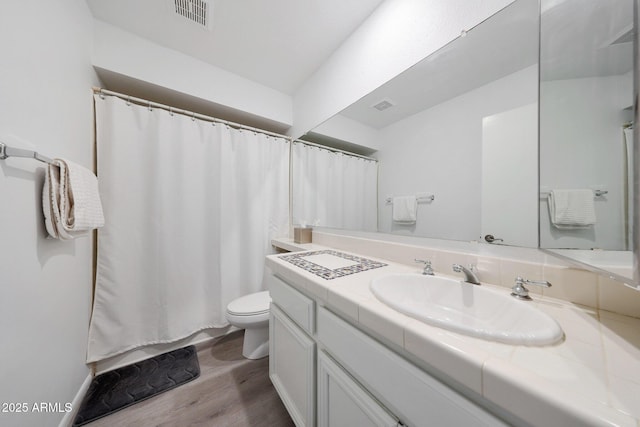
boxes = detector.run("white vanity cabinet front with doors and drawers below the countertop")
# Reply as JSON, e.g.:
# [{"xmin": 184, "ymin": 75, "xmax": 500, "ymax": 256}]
[{"xmin": 269, "ymin": 276, "xmax": 507, "ymax": 427}]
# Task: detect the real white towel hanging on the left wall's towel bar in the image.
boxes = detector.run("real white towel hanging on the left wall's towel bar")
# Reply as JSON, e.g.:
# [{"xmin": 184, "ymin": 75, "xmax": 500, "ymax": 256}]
[{"xmin": 42, "ymin": 159, "xmax": 104, "ymax": 240}]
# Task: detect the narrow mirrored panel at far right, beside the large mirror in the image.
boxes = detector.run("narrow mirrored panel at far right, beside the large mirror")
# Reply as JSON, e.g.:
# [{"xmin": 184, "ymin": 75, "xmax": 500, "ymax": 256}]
[{"xmin": 540, "ymin": 0, "xmax": 637, "ymax": 288}]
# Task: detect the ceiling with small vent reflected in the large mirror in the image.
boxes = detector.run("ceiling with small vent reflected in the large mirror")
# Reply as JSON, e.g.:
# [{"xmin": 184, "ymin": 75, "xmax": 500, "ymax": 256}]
[{"xmin": 340, "ymin": 0, "xmax": 539, "ymax": 129}]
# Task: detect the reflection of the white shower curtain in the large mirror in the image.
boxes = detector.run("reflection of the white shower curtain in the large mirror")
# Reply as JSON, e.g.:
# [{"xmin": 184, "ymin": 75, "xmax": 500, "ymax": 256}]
[{"xmin": 292, "ymin": 142, "xmax": 378, "ymax": 231}]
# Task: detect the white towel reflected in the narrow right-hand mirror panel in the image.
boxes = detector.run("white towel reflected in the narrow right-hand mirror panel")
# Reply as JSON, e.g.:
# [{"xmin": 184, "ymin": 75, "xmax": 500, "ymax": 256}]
[{"xmin": 548, "ymin": 189, "xmax": 596, "ymax": 229}]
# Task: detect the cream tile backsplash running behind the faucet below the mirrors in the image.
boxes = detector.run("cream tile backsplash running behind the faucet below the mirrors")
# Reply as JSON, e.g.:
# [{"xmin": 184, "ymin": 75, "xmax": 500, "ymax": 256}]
[{"xmin": 313, "ymin": 231, "xmax": 640, "ymax": 318}]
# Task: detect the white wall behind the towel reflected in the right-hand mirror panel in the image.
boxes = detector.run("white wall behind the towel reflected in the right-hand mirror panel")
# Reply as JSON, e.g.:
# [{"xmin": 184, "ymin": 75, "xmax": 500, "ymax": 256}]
[{"xmin": 540, "ymin": 73, "xmax": 633, "ymax": 250}]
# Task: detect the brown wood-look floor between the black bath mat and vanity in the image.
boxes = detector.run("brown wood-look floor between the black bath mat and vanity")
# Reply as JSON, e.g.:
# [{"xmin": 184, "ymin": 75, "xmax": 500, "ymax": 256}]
[{"xmin": 86, "ymin": 331, "xmax": 294, "ymax": 427}]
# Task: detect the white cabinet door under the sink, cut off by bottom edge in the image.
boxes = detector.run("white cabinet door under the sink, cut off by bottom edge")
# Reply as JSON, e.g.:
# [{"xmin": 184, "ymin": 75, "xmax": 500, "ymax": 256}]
[{"xmin": 318, "ymin": 352, "xmax": 398, "ymax": 427}]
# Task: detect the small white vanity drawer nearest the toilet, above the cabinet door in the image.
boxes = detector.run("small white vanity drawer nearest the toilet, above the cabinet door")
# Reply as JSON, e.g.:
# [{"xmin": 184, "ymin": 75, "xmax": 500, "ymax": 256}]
[{"xmin": 269, "ymin": 276, "xmax": 315, "ymax": 335}]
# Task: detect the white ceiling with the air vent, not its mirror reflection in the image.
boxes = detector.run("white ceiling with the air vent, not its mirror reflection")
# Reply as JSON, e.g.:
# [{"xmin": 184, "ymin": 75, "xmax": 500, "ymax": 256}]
[{"xmin": 86, "ymin": 0, "xmax": 383, "ymax": 95}]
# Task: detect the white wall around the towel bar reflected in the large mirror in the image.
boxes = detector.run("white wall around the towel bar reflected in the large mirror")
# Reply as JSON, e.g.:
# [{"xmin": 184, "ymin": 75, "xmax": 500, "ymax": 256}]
[{"xmin": 376, "ymin": 65, "xmax": 538, "ymax": 240}]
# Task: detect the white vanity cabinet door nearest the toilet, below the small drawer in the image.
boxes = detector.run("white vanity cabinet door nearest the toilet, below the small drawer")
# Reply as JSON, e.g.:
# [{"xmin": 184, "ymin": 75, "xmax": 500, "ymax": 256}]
[{"xmin": 269, "ymin": 304, "xmax": 316, "ymax": 427}]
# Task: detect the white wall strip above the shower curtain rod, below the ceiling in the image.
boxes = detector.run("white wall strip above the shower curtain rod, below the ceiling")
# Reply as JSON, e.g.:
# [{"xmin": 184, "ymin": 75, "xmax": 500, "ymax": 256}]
[{"xmin": 92, "ymin": 21, "xmax": 293, "ymax": 128}]
